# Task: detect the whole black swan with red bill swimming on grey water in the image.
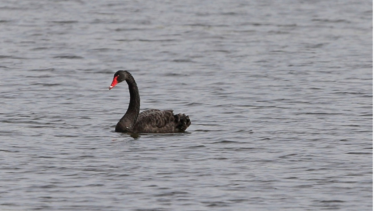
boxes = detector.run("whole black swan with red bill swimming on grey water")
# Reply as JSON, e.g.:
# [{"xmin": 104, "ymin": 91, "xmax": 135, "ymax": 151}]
[{"xmin": 109, "ymin": 70, "xmax": 191, "ymax": 133}]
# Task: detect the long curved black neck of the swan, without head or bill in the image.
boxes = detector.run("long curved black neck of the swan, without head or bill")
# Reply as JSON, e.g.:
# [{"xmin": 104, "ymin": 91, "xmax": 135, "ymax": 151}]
[{"xmin": 116, "ymin": 74, "xmax": 141, "ymax": 132}]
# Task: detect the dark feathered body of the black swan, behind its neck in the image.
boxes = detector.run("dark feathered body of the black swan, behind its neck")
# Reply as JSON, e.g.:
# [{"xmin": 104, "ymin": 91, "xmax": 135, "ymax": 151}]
[{"xmin": 133, "ymin": 109, "xmax": 191, "ymax": 133}]
